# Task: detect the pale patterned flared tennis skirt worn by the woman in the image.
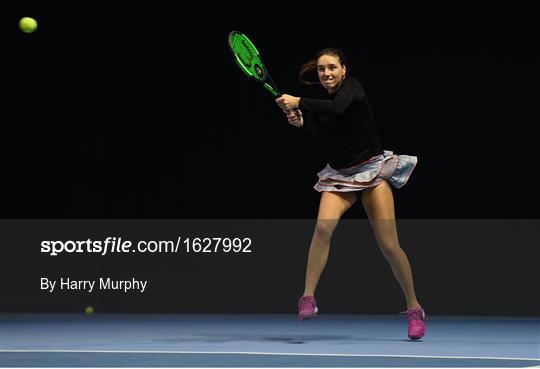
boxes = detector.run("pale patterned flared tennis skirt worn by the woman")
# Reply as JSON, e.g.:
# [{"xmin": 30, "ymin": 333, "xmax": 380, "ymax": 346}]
[{"xmin": 314, "ymin": 150, "xmax": 418, "ymax": 192}]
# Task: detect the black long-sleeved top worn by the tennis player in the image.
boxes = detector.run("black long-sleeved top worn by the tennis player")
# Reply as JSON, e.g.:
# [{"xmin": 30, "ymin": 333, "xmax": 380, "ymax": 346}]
[{"xmin": 299, "ymin": 77, "xmax": 383, "ymax": 169}]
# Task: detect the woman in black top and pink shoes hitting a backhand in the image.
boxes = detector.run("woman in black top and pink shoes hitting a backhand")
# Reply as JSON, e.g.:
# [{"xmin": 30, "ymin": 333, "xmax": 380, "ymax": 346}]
[{"xmin": 276, "ymin": 49, "xmax": 426, "ymax": 340}]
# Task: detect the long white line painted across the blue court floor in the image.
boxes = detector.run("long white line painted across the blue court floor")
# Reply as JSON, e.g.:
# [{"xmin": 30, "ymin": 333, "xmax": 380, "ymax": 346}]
[{"xmin": 0, "ymin": 349, "xmax": 540, "ymax": 361}]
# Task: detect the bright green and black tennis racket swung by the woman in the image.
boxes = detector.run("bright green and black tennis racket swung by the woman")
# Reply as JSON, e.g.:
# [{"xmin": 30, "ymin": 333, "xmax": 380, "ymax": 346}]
[{"xmin": 229, "ymin": 31, "xmax": 300, "ymax": 121}]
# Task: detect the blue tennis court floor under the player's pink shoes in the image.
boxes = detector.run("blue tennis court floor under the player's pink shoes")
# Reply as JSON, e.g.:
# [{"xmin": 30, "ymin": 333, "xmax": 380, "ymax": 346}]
[{"xmin": 0, "ymin": 314, "xmax": 540, "ymax": 367}]
